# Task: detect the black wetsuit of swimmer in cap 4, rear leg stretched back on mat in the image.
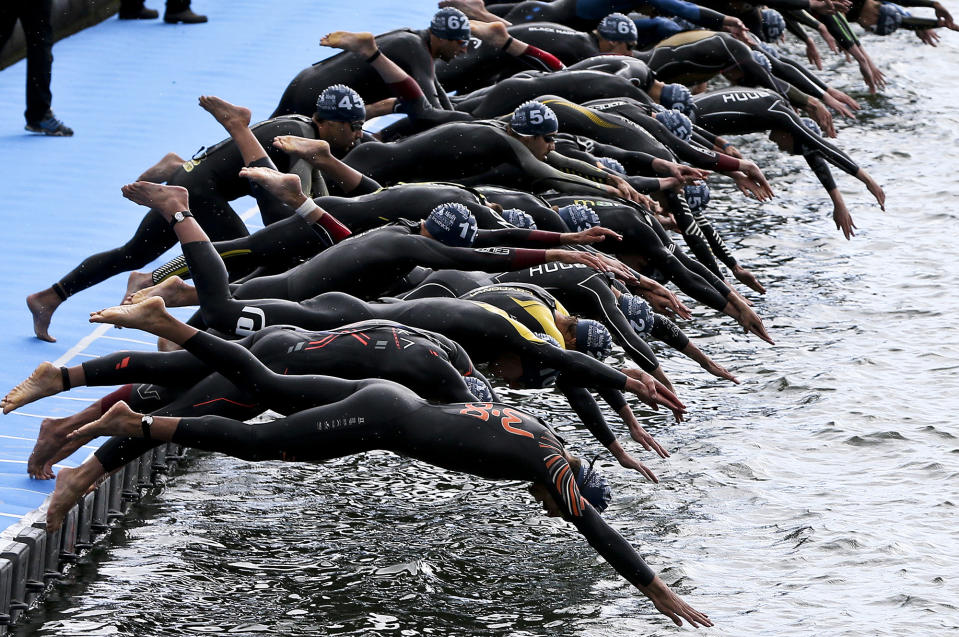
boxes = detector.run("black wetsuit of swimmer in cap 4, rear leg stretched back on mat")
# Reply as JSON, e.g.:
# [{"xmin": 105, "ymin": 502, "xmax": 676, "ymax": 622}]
[{"xmin": 53, "ymin": 115, "xmax": 317, "ymax": 298}]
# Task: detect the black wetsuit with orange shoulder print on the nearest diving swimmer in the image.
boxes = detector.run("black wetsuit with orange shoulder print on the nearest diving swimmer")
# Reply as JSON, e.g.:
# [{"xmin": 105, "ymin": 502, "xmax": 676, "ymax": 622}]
[{"xmin": 101, "ymin": 332, "xmax": 654, "ymax": 586}]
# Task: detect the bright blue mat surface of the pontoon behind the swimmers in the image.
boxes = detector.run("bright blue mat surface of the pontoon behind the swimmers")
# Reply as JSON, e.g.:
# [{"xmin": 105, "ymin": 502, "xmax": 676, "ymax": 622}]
[{"xmin": 0, "ymin": 0, "xmax": 436, "ymax": 529}]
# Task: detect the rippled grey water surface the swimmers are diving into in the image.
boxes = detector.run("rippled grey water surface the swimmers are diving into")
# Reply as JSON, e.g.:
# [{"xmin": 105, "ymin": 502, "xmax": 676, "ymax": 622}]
[{"xmin": 18, "ymin": 24, "xmax": 959, "ymax": 636}]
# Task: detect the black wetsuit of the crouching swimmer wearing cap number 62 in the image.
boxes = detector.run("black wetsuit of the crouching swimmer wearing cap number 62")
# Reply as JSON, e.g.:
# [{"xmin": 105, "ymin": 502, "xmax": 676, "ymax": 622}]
[{"xmin": 273, "ymin": 29, "xmax": 453, "ymax": 116}]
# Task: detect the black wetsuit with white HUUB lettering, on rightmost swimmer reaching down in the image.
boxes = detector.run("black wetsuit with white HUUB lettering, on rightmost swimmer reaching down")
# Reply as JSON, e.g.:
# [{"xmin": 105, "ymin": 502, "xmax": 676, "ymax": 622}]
[{"xmin": 694, "ymin": 88, "xmax": 859, "ymax": 191}]
